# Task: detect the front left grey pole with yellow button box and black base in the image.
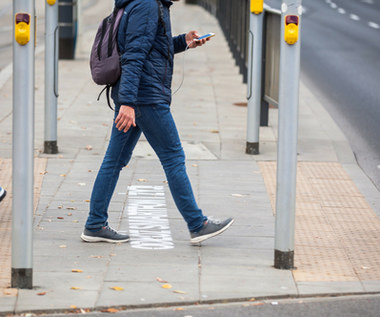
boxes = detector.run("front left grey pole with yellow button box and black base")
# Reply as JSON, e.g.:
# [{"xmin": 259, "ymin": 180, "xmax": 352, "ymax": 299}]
[{"xmin": 11, "ymin": 0, "xmax": 35, "ymax": 288}]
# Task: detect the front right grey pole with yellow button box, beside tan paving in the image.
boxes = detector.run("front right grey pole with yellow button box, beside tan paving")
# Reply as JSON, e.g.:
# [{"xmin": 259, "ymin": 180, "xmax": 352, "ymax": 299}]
[{"xmin": 274, "ymin": 0, "xmax": 302, "ymax": 269}]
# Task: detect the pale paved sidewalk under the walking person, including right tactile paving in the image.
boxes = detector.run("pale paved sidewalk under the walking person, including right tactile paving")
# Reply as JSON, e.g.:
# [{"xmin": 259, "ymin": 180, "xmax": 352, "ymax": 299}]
[{"xmin": 0, "ymin": 1, "xmax": 380, "ymax": 314}]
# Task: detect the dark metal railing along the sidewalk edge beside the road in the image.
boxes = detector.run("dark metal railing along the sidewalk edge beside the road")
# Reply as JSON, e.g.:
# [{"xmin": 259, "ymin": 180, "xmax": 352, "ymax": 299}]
[{"xmin": 191, "ymin": 0, "xmax": 281, "ymax": 122}]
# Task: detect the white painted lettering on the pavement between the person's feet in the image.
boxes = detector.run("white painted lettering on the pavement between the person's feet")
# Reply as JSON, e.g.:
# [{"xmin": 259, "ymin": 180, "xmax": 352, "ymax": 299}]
[{"xmin": 127, "ymin": 186, "xmax": 174, "ymax": 250}]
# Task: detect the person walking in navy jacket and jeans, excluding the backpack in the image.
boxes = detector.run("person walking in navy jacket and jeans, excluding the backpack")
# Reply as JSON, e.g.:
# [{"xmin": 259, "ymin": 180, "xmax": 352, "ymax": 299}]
[{"xmin": 81, "ymin": 0, "xmax": 234, "ymax": 244}]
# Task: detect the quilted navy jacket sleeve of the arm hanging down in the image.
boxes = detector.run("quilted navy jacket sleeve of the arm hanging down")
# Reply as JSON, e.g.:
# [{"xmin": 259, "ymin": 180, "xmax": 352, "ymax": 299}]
[{"xmin": 119, "ymin": 0, "xmax": 158, "ymax": 107}]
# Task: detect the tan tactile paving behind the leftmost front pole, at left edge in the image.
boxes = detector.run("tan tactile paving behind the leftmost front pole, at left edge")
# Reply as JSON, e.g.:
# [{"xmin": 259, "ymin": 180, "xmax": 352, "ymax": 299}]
[{"xmin": 0, "ymin": 158, "xmax": 47, "ymax": 296}]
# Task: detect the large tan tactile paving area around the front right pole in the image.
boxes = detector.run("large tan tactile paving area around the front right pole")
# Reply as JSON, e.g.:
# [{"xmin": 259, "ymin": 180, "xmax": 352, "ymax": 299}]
[{"xmin": 259, "ymin": 162, "xmax": 380, "ymax": 282}]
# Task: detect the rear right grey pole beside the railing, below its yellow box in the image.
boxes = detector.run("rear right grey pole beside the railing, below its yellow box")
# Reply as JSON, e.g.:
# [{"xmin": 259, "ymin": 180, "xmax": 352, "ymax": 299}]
[{"xmin": 246, "ymin": 4, "xmax": 264, "ymax": 154}]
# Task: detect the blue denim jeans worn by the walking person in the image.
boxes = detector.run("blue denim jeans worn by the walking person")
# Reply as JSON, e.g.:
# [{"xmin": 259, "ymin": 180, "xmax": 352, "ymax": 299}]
[{"xmin": 86, "ymin": 104, "xmax": 207, "ymax": 232}]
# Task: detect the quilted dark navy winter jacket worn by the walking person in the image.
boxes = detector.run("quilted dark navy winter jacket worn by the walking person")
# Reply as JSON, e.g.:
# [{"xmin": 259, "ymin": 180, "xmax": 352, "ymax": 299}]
[{"xmin": 111, "ymin": 0, "xmax": 186, "ymax": 107}]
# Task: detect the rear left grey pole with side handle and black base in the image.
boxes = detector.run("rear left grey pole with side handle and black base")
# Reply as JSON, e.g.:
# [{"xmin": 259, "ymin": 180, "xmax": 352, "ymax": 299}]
[{"xmin": 44, "ymin": 0, "xmax": 59, "ymax": 154}]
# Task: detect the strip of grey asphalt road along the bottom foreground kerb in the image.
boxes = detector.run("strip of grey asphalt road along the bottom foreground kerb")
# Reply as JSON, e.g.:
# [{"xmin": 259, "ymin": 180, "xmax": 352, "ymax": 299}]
[{"xmin": 46, "ymin": 295, "xmax": 380, "ymax": 317}]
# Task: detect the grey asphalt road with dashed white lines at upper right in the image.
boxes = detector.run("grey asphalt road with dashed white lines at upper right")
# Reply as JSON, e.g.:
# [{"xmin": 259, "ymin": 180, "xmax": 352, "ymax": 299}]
[{"xmin": 265, "ymin": 0, "xmax": 380, "ymax": 190}]
